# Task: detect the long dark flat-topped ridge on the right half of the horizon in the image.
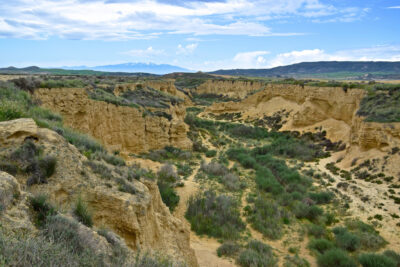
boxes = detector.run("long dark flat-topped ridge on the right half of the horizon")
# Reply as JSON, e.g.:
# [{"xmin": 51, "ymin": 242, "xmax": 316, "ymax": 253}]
[{"xmin": 209, "ymin": 61, "xmax": 400, "ymax": 78}]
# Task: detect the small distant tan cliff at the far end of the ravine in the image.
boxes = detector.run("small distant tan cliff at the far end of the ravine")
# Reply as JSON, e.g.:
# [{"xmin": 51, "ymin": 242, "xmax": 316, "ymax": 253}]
[{"xmin": 193, "ymin": 80, "xmax": 265, "ymax": 99}]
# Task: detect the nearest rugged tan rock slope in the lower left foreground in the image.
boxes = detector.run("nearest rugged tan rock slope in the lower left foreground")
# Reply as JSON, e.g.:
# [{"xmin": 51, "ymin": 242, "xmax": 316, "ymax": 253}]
[{"xmin": 0, "ymin": 119, "xmax": 197, "ymax": 266}]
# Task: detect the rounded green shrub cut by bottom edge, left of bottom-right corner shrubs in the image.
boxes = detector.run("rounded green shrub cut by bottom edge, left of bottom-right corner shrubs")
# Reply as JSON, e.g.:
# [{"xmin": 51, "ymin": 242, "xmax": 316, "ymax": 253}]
[{"xmin": 317, "ymin": 248, "xmax": 357, "ymax": 267}]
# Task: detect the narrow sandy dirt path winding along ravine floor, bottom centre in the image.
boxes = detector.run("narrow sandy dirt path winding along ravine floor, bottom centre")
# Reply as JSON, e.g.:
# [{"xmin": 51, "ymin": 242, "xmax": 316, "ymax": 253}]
[{"xmin": 173, "ymin": 159, "xmax": 236, "ymax": 267}]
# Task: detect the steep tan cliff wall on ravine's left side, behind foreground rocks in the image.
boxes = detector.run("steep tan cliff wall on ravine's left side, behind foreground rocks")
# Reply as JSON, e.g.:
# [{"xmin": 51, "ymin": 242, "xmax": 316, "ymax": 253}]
[{"xmin": 34, "ymin": 88, "xmax": 192, "ymax": 153}]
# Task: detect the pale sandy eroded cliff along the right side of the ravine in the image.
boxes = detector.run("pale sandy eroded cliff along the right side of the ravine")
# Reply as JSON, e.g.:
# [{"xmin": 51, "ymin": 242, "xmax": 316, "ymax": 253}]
[{"xmin": 206, "ymin": 84, "xmax": 400, "ymax": 155}]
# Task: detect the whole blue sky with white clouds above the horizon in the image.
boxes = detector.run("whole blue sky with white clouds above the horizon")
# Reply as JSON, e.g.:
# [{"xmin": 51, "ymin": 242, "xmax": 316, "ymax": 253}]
[{"xmin": 0, "ymin": 0, "xmax": 400, "ymax": 71}]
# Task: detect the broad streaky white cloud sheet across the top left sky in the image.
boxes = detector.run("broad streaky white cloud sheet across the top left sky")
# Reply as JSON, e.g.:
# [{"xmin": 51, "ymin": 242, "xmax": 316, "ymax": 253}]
[{"xmin": 0, "ymin": 0, "xmax": 368, "ymax": 40}]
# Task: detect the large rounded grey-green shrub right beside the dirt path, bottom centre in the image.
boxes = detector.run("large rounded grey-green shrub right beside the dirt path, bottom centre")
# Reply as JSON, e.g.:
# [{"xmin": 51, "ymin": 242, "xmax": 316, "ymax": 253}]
[{"xmin": 185, "ymin": 191, "xmax": 246, "ymax": 240}]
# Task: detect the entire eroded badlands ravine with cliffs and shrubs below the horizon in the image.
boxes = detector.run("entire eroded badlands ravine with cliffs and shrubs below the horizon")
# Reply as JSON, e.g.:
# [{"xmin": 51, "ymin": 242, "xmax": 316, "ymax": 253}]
[{"xmin": 0, "ymin": 73, "xmax": 400, "ymax": 267}]
